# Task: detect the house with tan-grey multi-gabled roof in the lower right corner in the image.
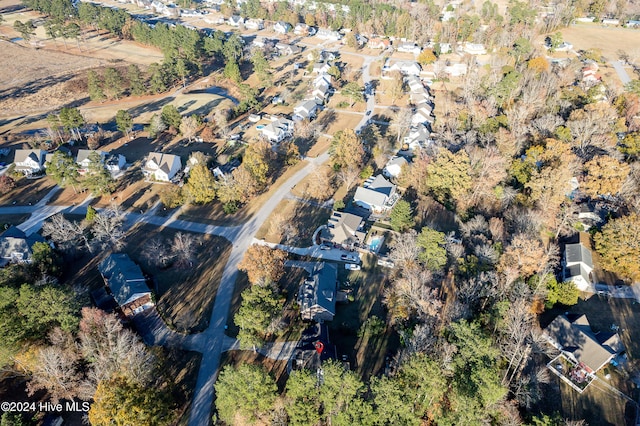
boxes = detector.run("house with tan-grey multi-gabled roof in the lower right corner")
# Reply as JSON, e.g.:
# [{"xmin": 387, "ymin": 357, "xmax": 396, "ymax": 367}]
[{"xmin": 543, "ymin": 314, "xmax": 625, "ymax": 376}]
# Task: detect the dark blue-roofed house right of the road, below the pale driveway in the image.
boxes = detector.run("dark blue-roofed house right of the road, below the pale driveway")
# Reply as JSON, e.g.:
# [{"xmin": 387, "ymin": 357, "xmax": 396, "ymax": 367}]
[{"xmin": 298, "ymin": 262, "xmax": 338, "ymax": 322}]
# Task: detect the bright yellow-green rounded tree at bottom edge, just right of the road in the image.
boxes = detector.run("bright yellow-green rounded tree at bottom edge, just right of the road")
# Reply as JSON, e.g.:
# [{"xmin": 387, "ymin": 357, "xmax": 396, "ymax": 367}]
[{"xmin": 215, "ymin": 364, "xmax": 278, "ymax": 424}]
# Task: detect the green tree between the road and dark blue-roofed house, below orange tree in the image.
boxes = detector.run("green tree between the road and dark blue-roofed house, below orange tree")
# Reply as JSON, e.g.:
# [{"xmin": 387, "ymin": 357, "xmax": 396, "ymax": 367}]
[{"xmin": 233, "ymin": 285, "xmax": 282, "ymax": 349}]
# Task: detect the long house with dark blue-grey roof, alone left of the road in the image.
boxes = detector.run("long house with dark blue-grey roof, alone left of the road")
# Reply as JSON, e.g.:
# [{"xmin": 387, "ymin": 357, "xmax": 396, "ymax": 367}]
[{"xmin": 98, "ymin": 253, "xmax": 154, "ymax": 317}]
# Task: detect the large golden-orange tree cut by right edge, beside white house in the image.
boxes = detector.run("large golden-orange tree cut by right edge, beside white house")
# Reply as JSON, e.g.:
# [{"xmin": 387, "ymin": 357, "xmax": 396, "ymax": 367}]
[{"xmin": 594, "ymin": 213, "xmax": 640, "ymax": 282}]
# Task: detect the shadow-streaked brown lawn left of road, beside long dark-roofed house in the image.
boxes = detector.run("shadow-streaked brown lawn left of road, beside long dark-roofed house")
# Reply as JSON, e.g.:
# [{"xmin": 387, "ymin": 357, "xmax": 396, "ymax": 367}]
[{"xmin": 126, "ymin": 225, "xmax": 231, "ymax": 333}]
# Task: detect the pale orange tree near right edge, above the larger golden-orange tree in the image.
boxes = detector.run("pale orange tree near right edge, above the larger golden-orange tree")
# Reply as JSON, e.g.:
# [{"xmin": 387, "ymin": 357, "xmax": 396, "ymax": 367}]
[{"xmin": 582, "ymin": 155, "xmax": 631, "ymax": 198}]
